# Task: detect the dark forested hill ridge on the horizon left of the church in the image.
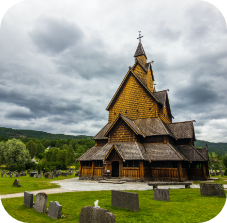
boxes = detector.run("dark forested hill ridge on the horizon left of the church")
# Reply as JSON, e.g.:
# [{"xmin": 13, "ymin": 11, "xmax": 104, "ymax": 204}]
[{"xmin": 0, "ymin": 127, "xmax": 93, "ymax": 140}]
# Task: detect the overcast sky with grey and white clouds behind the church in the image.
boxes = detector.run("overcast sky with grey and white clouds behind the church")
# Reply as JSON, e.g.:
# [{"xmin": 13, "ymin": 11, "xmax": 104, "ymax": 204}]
[{"xmin": 0, "ymin": 0, "xmax": 227, "ymax": 142}]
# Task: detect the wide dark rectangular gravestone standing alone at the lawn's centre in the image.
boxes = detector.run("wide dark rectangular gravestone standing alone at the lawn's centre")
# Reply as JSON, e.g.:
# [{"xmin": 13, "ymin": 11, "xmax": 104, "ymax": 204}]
[{"xmin": 111, "ymin": 190, "xmax": 139, "ymax": 211}]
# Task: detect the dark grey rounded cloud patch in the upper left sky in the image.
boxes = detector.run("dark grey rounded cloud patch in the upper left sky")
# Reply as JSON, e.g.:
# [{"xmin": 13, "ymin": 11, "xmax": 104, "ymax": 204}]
[{"xmin": 30, "ymin": 17, "xmax": 83, "ymax": 54}]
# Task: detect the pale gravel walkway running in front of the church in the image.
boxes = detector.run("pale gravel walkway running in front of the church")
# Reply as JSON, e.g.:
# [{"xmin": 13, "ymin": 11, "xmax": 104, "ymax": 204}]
[{"xmin": 0, "ymin": 177, "xmax": 227, "ymax": 200}]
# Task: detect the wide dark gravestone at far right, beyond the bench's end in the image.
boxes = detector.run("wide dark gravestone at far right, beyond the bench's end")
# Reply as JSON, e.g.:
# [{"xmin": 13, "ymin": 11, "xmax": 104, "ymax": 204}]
[{"xmin": 199, "ymin": 183, "xmax": 225, "ymax": 197}]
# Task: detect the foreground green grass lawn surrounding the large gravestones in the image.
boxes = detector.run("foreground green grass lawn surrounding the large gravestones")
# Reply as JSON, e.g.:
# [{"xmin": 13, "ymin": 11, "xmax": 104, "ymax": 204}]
[{"xmin": 1, "ymin": 188, "xmax": 227, "ymax": 223}]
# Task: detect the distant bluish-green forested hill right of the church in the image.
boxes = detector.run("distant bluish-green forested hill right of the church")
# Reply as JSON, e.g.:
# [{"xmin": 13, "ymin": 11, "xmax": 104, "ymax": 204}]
[{"xmin": 195, "ymin": 140, "xmax": 227, "ymax": 156}]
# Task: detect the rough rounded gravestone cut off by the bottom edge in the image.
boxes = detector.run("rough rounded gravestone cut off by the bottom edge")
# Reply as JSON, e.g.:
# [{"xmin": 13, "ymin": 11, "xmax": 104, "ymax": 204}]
[{"xmin": 79, "ymin": 206, "xmax": 115, "ymax": 223}]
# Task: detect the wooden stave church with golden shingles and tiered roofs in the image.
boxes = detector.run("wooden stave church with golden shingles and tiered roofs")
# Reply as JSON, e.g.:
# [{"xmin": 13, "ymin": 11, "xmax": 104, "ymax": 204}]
[{"xmin": 78, "ymin": 36, "xmax": 209, "ymax": 181}]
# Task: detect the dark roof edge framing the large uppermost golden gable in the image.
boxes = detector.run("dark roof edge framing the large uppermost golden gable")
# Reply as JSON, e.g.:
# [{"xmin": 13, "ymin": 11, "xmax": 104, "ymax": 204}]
[{"xmin": 106, "ymin": 68, "xmax": 161, "ymax": 110}]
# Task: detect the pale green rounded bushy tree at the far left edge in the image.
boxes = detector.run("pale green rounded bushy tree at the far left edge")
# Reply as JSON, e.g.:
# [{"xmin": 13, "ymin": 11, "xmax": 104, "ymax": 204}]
[{"xmin": 0, "ymin": 139, "xmax": 31, "ymax": 165}]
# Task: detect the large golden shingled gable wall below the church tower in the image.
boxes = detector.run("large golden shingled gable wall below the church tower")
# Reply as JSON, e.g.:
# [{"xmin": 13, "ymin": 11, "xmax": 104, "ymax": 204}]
[{"xmin": 108, "ymin": 74, "xmax": 158, "ymax": 122}]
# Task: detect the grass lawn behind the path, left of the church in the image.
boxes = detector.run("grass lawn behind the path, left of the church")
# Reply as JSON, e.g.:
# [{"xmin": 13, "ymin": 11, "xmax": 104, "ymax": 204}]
[{"xmin": 0, "ymin": 174, "xmax": 75, "ymax": 195}]
